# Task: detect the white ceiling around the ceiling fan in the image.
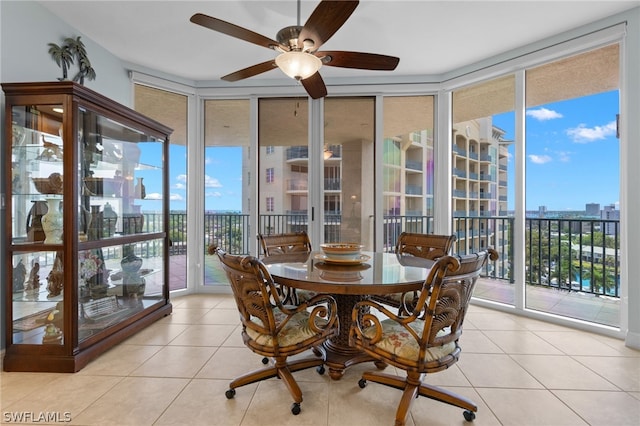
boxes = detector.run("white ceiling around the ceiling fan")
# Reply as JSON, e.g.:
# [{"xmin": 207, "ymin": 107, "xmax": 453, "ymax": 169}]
[{"xmin": 39, "ymin": 0, "xmax": 640, "ymax": 84}]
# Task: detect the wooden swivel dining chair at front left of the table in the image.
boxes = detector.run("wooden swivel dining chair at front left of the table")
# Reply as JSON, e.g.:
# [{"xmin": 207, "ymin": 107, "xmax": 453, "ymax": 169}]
[{"xmin": 209, "ymin": 247, "xmax": 338, "ymax": 414}]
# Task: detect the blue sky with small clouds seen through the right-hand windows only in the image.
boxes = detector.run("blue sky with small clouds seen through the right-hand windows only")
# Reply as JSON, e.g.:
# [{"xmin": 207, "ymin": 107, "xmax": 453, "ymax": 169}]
[{"xmin": 493, "ymin": 90, "xmax": 620, "ymax": 211}]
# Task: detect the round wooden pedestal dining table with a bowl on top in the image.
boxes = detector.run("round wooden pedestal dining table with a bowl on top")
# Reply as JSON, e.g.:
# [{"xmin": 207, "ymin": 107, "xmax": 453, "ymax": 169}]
[{"xmin": 262, "ymin": 251, "xmax": 434, "ymax": 380}]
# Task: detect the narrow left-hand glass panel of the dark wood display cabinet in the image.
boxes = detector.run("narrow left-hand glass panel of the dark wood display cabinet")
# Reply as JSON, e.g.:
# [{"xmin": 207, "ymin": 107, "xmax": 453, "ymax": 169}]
[{"xmin": 8, "ymin": 104, "xmax": 65, "ymax": 344}]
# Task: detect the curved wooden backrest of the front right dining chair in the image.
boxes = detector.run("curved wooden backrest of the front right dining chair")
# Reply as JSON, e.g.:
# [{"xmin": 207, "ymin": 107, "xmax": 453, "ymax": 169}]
[{"xmin": 418, "ymin": 248, "xmax": 498, "ymax": 359}]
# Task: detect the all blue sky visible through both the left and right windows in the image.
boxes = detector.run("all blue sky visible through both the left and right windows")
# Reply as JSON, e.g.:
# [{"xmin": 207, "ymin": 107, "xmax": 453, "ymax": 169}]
[{"xmin": 142, "ymin": 91, "xmax": 620, "ymax": 215}]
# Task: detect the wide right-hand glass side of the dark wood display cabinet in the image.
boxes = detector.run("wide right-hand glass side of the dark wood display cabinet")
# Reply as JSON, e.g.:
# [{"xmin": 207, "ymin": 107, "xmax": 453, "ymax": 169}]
[{"xmin": 77, "ymin": 107, "xmax": 164, "ymax": 342}]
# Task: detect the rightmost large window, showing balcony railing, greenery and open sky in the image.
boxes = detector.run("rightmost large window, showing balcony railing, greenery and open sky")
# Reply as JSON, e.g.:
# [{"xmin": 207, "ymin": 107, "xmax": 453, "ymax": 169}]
[{"xmin": 525, "ymin": 44, "xmax": 620, "ymax": 326}]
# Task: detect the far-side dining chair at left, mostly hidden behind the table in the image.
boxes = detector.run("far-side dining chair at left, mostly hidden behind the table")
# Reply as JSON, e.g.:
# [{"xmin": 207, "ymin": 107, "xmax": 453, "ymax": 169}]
[{"xmin": 258, "ymin": 231, "xmax": 317, "ymax": 305}]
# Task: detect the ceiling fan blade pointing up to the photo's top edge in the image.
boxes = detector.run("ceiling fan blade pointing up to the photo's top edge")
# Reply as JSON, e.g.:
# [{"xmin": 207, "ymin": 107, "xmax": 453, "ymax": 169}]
[{"xmin": 298, "ymin": 0, "xmax": 359, "ymax": 52}]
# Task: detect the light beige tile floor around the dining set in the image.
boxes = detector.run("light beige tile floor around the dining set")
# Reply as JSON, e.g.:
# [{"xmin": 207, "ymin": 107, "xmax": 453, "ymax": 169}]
[{"xmin": 0, "ymin": 294, "xmax": 640, "ymax": 426}]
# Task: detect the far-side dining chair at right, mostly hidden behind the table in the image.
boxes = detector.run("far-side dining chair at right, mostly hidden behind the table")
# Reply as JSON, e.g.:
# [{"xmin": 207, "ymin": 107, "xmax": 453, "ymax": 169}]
[{"xmin": 373, "ymin": 232, "xmax": 456, "ymax": 315}]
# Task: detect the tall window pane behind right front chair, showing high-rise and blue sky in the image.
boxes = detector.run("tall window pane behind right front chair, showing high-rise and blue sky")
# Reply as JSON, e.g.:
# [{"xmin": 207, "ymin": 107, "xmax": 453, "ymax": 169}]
[{"xmin": 451, "ymin": 75, "xmax": 515, "ymax": 305}]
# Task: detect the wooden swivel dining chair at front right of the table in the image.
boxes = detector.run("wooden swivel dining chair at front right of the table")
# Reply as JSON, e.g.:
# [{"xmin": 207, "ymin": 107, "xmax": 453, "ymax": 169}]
[{"xmin": 349, "ymin": 249, "xmax": 498, "ymax": 426}]
